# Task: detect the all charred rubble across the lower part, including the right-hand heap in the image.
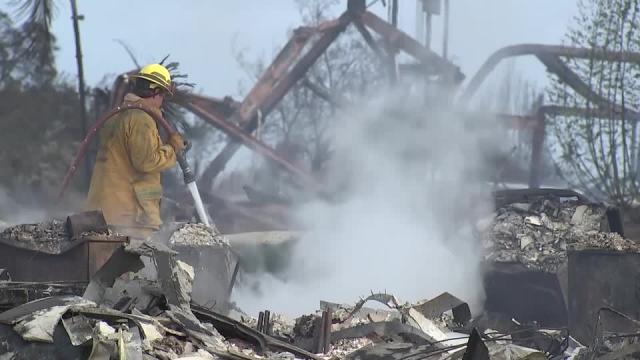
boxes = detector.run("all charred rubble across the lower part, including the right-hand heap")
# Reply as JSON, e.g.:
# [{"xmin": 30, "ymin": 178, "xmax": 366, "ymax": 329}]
[{"xmin": 0, "ymin": 189, "xmax": 640, "ymax": 359}]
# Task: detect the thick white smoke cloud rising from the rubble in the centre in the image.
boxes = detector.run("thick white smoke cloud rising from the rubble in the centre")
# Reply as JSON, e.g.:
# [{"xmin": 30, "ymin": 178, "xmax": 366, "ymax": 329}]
[{"xmin": 234, "ymin": 88, "xmax": 495, "ymax": 315}]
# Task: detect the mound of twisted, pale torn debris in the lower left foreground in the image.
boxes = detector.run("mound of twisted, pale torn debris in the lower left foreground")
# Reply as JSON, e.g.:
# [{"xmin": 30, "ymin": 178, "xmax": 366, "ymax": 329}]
[{"xmin": 0, "ymin": 242, "xmax": 314, "ymax": 360}]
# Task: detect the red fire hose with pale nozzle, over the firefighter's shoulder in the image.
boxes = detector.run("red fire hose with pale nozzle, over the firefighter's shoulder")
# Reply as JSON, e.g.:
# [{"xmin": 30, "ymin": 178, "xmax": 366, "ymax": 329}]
[{"xmin": 58, "ymin": 104, "xmax": 209, "ymax": 225}]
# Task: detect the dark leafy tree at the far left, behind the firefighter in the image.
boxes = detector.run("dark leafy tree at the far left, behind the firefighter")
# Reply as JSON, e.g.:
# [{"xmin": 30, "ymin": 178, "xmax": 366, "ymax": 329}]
[{"xmin": 0, "ymin": 9, "xmax": 82, "ymax": 202}]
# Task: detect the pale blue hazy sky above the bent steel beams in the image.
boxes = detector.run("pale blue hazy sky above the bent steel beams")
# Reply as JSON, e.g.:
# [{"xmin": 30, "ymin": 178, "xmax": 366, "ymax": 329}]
[{"xmin": 7, "ymin": 0, "xmax": 576, "ymax": 96}]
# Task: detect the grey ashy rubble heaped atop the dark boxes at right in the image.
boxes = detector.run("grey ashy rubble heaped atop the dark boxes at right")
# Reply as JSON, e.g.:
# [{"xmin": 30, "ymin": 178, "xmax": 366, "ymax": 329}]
[{"xmin": 481, "ymin": 197, "xmax": 640, "ymax": 272}]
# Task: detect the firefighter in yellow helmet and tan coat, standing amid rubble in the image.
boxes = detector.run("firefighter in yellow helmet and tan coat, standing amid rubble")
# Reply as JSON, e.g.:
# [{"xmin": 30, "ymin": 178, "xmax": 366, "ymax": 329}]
[{"xmin": 86, "ymin": 64, "xmax": 185, "ymax": 239}]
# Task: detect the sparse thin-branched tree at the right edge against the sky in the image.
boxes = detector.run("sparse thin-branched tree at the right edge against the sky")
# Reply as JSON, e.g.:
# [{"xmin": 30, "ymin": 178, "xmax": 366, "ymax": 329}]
[{"xmin": 547, "ymin": 0, "xmax": 640, "ymax": 206}]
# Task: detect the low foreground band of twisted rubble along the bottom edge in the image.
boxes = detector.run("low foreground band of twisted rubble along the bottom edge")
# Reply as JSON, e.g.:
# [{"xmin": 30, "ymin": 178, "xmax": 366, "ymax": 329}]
[{"xmin": 0, "ymin": 242, "xmax": 632, "ymax": 360}]
